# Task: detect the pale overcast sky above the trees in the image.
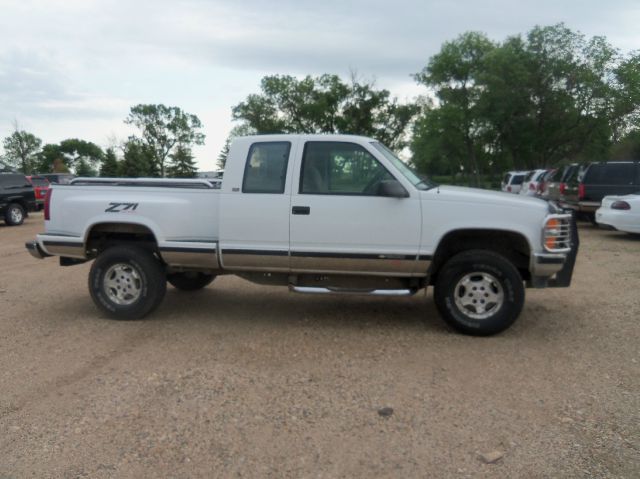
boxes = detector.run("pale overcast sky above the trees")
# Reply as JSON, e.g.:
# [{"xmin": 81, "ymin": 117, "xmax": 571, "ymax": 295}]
[{"xmin": 0, "ymin": 0, "xmax": 640, "ymax": 170}]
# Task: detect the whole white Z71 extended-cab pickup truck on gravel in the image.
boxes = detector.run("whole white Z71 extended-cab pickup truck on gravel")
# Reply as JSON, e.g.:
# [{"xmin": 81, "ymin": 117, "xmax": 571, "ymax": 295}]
[{"xmin": 26, "ymin": 135, "xmax": 578, "ymax": 335}]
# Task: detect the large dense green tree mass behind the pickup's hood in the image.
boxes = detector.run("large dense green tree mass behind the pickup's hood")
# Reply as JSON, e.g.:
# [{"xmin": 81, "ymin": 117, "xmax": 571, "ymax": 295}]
[{"xmin": 411, "ymin": 24, "xmax": 640, "ymax": 177}]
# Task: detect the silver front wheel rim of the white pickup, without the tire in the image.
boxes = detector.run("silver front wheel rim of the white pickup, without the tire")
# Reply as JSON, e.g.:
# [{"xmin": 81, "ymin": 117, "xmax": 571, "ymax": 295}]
[{"xmin": 454, "ymin": 272, "xmax": 504, "ymax": 319}]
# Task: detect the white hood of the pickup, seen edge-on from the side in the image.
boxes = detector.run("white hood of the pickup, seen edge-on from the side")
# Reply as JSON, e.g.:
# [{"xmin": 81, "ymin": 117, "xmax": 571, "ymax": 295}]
[{"xmin": 422, "ymin": 185, "xmax": 549, "ymax": 212}]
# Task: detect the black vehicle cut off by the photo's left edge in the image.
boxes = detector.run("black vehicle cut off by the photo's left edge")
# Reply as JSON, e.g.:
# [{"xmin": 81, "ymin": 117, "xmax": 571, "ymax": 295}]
[{"xmin": 0, "ymin": 173, "xmax": 36, "ymax": 226}]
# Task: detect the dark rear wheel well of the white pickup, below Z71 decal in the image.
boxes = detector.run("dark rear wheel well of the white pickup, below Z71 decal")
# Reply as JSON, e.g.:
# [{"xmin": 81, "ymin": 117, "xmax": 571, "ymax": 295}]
[{"xmin": 86, "ymin": 223, "xmax": 158, "ymax": 256}]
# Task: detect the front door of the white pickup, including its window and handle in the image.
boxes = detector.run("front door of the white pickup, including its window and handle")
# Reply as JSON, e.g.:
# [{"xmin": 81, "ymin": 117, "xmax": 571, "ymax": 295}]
[{"xmin": 289, "ymin": 141, "xmax": 424, "ymax": 276}]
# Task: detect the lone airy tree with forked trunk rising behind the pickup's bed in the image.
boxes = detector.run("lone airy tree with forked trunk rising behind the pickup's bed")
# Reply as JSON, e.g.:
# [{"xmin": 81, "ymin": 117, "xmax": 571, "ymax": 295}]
[{"xmin": 125, "ymin": 104, "xmax": 204, "ymax": 177}]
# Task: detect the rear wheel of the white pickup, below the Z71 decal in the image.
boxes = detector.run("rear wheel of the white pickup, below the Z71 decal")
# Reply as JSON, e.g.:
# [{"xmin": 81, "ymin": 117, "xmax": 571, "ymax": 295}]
[{"xmin": 89, "ymin": 246, "xmax": 167, "ymax": 320}]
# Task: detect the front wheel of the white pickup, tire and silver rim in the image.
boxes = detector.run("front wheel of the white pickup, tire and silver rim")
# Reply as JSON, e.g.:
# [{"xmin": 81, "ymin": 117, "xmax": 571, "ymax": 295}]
[{"xmin": 434, "ymin": 250, "xmax": 524, "ymax": 336}]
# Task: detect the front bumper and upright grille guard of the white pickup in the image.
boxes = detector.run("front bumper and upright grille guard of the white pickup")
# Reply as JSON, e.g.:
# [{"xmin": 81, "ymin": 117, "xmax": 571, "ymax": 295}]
[{"xmin": 529, "ymin": 214, "xmax": 580, "ymax": 288}]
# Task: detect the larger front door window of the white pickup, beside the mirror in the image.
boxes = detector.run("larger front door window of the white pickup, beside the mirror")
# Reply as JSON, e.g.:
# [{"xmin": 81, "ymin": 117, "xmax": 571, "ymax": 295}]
[{"xmin": 300, "ymin": 141, "xmax": 394, "ymax": 196}]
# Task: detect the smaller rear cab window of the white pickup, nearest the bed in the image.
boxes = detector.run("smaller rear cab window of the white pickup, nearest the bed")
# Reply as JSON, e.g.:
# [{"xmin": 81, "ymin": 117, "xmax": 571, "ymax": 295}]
[{"xmin": 242, "ymin": 141, "xmax": 291, "ymax": 193}]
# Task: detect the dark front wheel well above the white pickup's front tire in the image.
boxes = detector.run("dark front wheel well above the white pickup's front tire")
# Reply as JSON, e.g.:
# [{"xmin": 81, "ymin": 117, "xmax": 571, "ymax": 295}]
[{"xmin": 429, "ymin": 229, "xmax": 531, "ymax": 284}]
